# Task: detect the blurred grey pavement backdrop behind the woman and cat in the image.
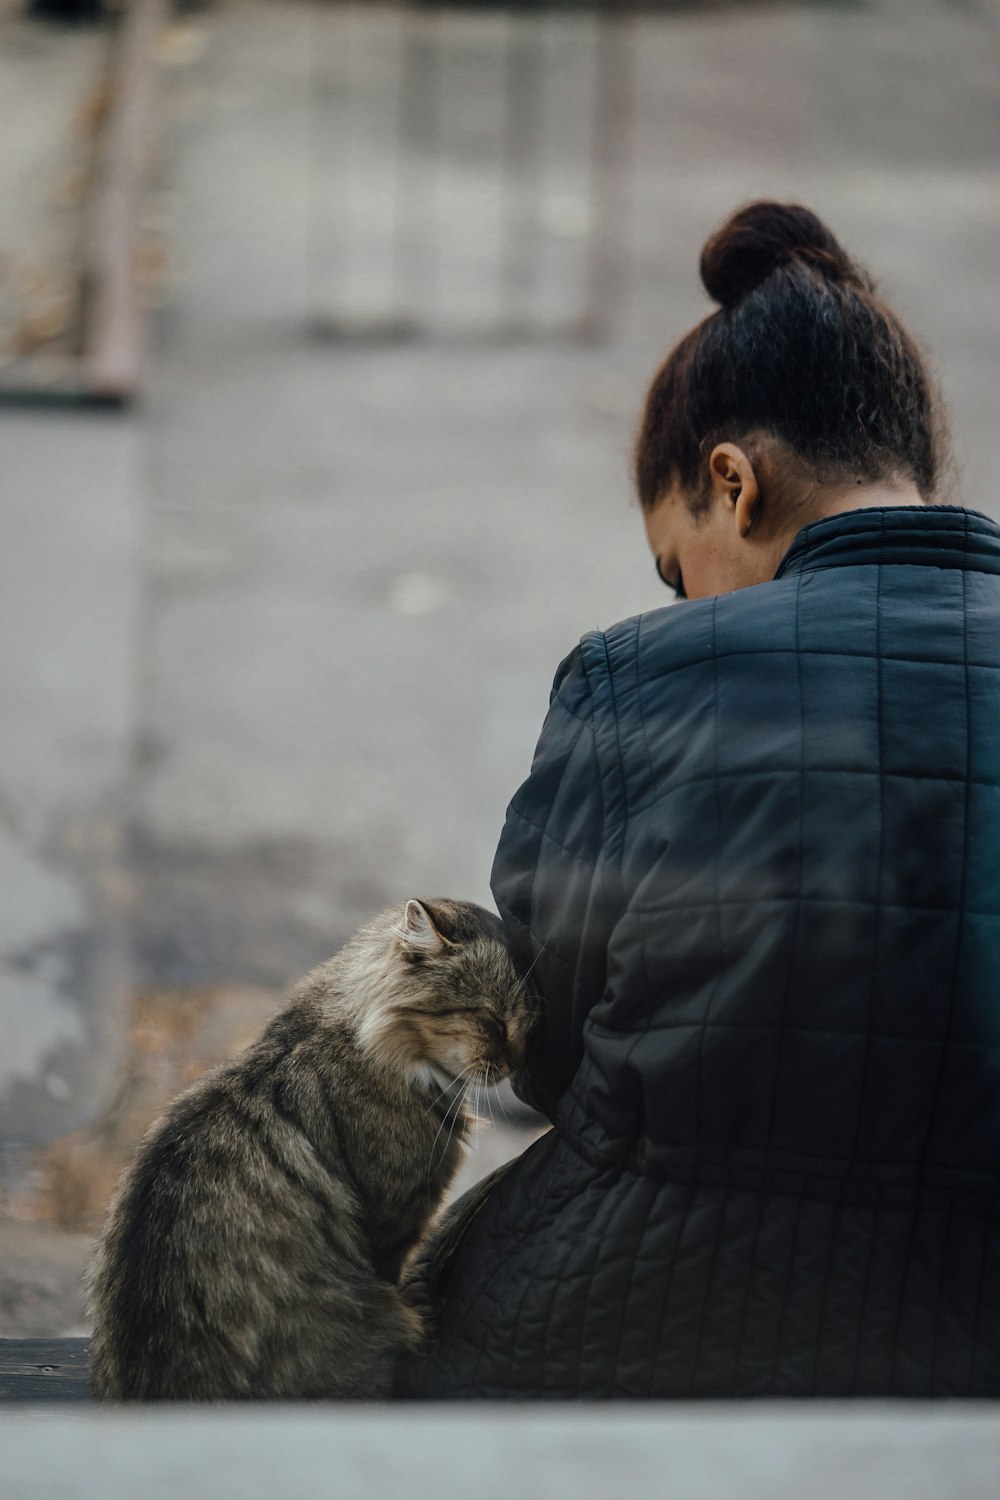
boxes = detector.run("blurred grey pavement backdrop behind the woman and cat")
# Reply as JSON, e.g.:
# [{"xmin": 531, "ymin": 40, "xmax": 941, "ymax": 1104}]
[{"xmin": 0, "ymin": 0, "xmax": 1000, "ymax": 1337}]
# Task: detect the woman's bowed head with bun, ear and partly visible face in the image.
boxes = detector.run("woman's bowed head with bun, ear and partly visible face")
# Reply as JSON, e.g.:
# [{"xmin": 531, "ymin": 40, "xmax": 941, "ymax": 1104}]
[{"xmin": 636, "ymin": 203, "xmax": 946, "ymax": 594}]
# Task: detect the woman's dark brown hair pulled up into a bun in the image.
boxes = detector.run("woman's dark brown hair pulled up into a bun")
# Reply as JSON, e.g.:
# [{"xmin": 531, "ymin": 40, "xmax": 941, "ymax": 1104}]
[{"xmin": 636, "ymin": 203, "xmax": 946, "ymax": 510}]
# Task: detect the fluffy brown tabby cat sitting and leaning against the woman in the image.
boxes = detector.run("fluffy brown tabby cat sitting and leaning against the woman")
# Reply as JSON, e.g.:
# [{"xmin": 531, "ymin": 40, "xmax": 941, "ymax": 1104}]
[{"xmin": 88, "ymin": 900, "xmax": 534, "ymax": 1401}]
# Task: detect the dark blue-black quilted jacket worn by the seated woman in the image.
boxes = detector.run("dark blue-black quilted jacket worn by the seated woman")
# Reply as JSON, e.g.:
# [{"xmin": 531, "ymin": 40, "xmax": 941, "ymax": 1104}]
[{"xmin": 406, "ymin": 507, "xmax": 1000, "ymax": 1398}]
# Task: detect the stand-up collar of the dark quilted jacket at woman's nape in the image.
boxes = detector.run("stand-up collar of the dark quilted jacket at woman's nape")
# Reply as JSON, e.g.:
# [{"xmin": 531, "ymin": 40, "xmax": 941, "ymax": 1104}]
[{"xmin": 775, "ymin": 506, "xmax": 1000, "ymax": 578}]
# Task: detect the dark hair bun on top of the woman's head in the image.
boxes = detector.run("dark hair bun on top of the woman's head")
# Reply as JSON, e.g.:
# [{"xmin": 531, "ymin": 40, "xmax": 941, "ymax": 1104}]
[{"xmin": 700, "ymin": 203, "xmax": 864, "ymax": 308}]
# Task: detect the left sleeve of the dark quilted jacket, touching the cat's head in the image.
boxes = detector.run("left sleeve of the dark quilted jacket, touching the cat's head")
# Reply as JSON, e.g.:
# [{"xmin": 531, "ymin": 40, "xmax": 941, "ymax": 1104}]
[{"xmin": 492, "ymin": 647, "xmax": 616, "ymax": 1119}]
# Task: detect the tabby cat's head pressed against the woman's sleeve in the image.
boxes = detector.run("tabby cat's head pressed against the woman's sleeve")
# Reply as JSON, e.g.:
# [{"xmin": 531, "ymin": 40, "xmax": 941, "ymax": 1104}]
[{"xmin": 358, "ymin": 900, "xmax": 538, "ymax": 1088}]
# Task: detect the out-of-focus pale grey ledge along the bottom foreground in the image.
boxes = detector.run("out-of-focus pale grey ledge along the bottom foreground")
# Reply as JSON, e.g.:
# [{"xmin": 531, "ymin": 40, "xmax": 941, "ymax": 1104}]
[{"xmin": 0, "ymin": 1403, "xmax": 1000, "ymax": 1500}]
